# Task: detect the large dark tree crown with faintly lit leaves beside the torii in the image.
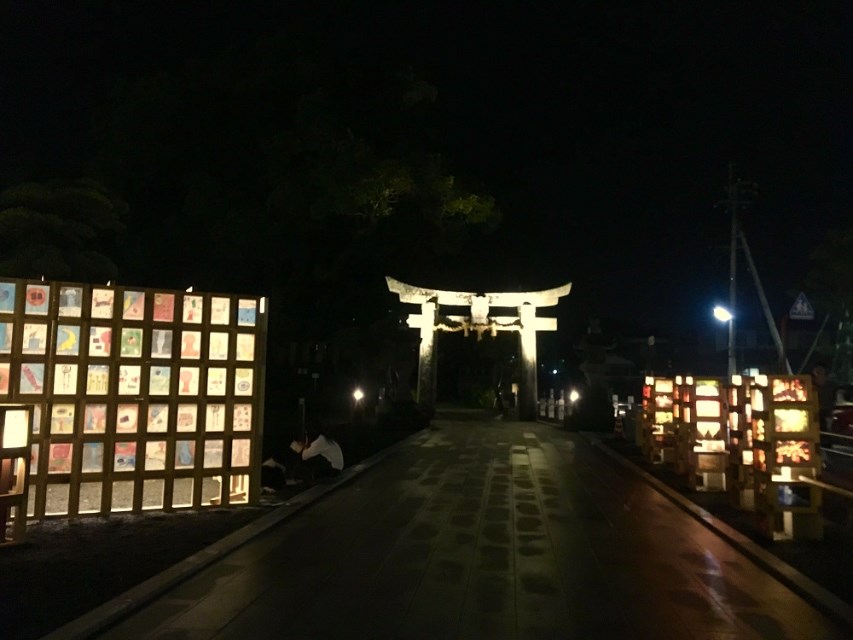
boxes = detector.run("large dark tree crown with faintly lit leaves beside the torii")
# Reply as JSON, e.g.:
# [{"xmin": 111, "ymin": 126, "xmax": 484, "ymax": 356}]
[{"xmin": 95, "ymin": 42, "xmax": 500, "ymax": 333}]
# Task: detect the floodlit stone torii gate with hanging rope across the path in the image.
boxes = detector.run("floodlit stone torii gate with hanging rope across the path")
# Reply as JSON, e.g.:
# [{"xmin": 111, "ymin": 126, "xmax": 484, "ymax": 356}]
[{"xmin": 385, "ymin": 276, "xmax": 572, "ymax": 420}]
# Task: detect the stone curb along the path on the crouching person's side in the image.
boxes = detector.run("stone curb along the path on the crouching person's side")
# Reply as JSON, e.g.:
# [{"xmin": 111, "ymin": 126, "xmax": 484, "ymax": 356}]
[{"xmin": 42, "ymin": 429, "xmax": 429, "ymax": 640}]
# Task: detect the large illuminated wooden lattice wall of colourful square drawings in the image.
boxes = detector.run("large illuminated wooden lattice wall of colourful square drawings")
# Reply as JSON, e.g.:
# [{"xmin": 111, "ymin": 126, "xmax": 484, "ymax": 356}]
[{"xmin": 0, "ymin": 279, "xmax": 266, "ymax": 519}]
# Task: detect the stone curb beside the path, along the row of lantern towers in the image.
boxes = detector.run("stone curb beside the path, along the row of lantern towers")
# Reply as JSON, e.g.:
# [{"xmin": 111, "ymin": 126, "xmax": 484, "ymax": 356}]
[{"xmin": 578, "ymin": 432, "xmax": 853, "ymax": 629}]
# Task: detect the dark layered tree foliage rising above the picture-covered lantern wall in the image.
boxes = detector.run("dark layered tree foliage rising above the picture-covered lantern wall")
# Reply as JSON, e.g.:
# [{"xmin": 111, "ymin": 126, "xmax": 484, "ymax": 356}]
[{"xmin": 0, "ymin": 180, "xmax": 127, "ymax": 281}]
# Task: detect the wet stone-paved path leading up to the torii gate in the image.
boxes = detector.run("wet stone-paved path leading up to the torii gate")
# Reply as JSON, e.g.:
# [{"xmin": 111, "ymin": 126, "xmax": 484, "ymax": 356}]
[{"xmin": 91, "ymin": 420, "xmax": 847, "ymax": 640}]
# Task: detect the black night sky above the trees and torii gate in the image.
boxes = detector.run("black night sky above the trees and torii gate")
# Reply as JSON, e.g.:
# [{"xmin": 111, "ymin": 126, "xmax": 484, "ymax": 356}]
[{"xmin": 0, "ymin": 0, "xmax": 853, "ymax": 340}]
